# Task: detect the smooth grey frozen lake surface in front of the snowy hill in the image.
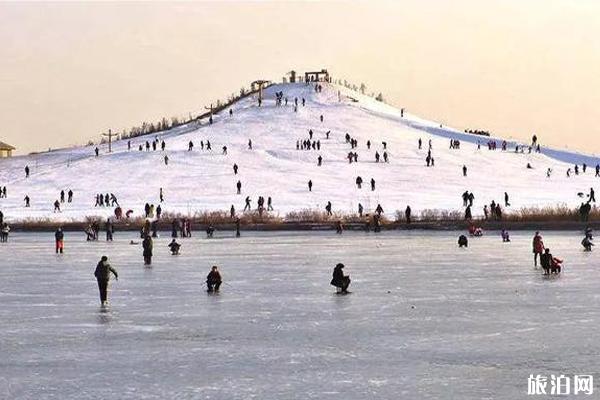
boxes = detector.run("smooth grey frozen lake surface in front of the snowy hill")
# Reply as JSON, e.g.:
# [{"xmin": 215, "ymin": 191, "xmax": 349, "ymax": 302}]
[{"xmin": 0, "ymin": 232, "xmax": 600, "ymax": 400}]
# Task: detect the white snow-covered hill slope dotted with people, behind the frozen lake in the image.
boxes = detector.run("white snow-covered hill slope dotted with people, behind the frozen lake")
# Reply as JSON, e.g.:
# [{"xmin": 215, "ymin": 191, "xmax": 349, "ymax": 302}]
[{"xmin": 0, "ymin": 84, "xmax": 597, "ymax": 221}]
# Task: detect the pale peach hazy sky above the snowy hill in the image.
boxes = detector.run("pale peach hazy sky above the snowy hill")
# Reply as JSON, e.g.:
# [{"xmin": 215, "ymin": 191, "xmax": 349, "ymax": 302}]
[{"xmin": 0, "ymin": 0, "xmax": 600, "ymax": 154}]
